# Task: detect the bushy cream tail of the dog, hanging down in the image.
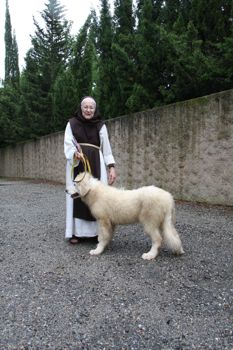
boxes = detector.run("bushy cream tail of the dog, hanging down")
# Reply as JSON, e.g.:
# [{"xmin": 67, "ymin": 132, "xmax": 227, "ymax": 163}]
[{"xmin": 162, "ymin": 201, "xmax": 184, "ymax": 255}]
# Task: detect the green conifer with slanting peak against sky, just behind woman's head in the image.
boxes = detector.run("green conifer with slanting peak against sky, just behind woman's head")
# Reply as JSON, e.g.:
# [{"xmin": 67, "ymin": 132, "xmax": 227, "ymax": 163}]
[{"xmin": 54, "ymin": 11, "xmax": 99, "ymax": 130}]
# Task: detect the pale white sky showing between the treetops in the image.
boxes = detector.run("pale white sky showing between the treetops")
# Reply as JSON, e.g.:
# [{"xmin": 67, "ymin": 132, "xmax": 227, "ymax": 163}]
[{"xmin": 0, "ymin": 0, "xmax": 104, "ymax": 79}]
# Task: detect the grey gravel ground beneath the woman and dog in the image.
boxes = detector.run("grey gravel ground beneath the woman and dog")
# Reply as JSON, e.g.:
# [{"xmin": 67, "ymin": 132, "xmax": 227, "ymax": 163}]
[{"xmin": 0, "ymin": 179, "xmax": 233, "ymax": 350}]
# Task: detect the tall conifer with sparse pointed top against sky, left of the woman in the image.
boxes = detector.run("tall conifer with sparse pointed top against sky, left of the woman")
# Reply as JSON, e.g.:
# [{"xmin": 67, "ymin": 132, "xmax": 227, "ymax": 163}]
[{"xmin": 22, "ymin": 0, "xmax": 70, "ymax": 135}]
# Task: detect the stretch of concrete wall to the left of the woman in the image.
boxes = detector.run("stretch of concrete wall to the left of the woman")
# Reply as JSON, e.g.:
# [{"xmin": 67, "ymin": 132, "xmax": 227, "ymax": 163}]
[{"xmin": 0, "ymin": 132, "xmax": 65, "ymax": 183}]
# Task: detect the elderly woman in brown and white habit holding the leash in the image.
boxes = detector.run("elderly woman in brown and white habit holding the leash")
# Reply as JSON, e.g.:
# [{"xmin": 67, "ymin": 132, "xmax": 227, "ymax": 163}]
[{"xmin": 64, "ymin": 96, "xmax": 116, "ymax": 244}]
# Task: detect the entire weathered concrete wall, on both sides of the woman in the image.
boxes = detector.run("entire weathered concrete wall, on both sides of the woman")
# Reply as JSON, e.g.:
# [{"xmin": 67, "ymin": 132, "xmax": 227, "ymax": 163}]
[{"xmin": 0, "ymin": 90, "xmax": 233, "ymax": 206}]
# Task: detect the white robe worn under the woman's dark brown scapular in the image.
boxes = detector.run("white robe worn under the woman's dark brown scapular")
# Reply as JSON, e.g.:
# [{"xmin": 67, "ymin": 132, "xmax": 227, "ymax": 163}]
[{"xmin": 64, "ymin": 122, "xmax": 115, "ymax": 238}]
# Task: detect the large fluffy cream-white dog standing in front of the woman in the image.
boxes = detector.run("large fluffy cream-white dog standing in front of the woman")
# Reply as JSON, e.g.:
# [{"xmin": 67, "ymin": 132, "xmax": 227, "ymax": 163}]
[{"xmin": 75, "ymin": 173, "xmax": 184, "ymax": 260}]
